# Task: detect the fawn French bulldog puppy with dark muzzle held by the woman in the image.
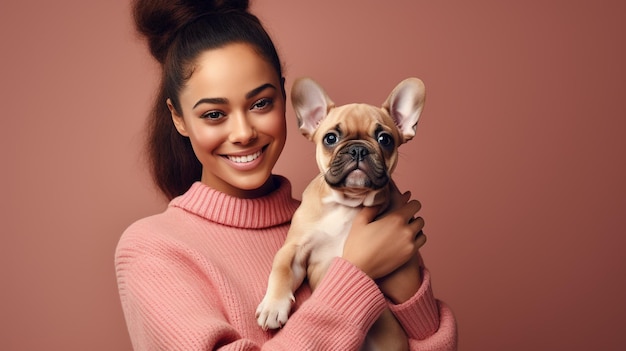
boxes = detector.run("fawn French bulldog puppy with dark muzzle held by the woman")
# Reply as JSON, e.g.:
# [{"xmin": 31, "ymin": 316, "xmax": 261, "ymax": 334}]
[{"xmin": 256, "ymin": 78, "xmax": 425, "ymax": 350}]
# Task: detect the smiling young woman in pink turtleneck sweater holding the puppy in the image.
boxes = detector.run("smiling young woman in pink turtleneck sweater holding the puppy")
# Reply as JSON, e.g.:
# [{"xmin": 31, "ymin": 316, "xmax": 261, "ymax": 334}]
[{"xmin": 115, "ymin": 0, "xmax": 457, "ymax": 351}]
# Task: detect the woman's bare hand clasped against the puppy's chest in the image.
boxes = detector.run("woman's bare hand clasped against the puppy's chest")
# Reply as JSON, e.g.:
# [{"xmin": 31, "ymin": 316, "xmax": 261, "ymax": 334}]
[{"xmin": 343, "ymin": 189, "xmax": 426, "ymax": 282}]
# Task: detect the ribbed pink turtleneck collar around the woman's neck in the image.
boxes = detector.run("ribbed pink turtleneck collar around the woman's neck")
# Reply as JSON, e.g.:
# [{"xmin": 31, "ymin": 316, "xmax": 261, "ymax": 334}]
[{"xmin": 170, "ymin": 176, "xmax": 300, "ymax": 229}]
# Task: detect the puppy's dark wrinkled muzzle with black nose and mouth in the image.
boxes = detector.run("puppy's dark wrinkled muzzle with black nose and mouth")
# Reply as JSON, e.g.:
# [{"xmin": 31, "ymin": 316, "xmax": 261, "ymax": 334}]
[{"xmin": 324, "ymin": 145, "xmax": 389, "ymax": 190}]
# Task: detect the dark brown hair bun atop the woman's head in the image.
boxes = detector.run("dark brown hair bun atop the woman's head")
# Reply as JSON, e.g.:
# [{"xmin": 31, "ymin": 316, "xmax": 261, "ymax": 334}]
[{"xmin": 132, "ymin": 0, "xmax": 250, "ymax": 63}]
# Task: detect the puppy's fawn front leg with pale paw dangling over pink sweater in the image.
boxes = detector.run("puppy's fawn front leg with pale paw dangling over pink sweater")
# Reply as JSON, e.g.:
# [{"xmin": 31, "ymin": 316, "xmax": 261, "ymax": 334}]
[{"xmin": 256, "ymin": 243, "xmax": 306, "ymax": 330}]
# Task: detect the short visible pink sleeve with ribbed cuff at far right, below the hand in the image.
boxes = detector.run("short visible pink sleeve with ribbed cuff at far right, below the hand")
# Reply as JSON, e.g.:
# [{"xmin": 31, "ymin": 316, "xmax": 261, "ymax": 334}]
[{"xmin": 389, "ymin": 266, "xmax": 457, "ymax": 351}]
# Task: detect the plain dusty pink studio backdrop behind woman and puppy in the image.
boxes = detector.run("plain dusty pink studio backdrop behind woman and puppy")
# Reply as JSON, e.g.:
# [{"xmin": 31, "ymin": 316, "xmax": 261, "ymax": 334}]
[{"xmin": 0, "ymin": 0, "xmax": 626, "ymax": 350}]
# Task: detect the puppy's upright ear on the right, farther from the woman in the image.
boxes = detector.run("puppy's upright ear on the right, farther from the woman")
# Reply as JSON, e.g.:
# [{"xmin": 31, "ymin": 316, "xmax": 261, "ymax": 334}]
[{"xmin": 382, "ymin": 78, "xmax": 426, "ymax": 143}]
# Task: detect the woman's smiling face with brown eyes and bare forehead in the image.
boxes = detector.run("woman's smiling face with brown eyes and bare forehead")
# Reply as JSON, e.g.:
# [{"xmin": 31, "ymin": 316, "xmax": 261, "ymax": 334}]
[{"xmin": 168, "ymin": 44, "xmax": 286, "ymax": 198}]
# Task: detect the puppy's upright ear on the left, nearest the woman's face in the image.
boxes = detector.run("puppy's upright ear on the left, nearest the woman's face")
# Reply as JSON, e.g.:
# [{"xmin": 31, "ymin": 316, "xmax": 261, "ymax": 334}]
[{"xmin": 291, "ymin": 78, "xmax": 335, "ymax": 140}]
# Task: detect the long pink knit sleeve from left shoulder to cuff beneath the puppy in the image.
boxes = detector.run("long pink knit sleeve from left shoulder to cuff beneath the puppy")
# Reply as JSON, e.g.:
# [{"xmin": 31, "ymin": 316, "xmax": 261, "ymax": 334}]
[{"xmin": 116, "ymin": 236, "xmax": 386, "ymax": 351}]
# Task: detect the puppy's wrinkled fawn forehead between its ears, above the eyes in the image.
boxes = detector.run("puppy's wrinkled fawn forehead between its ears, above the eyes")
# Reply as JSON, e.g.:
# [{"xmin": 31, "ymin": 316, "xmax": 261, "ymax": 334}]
[{"xmin": 321, "ymin": 104, "xmax": 396, "ymax": 139}]
